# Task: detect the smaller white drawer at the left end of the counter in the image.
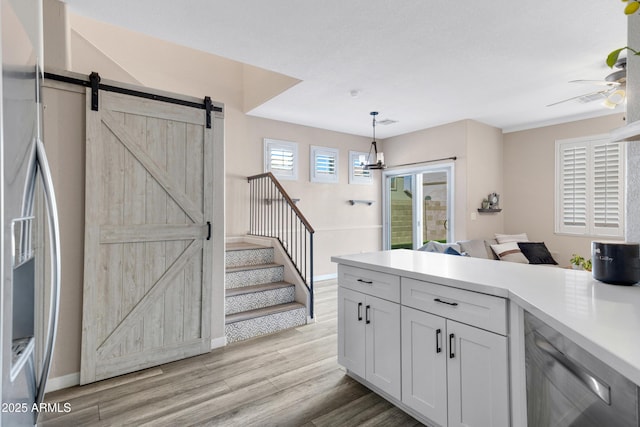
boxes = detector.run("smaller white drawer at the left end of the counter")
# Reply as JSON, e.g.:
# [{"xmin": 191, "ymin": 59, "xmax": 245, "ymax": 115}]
[{"xmin": 338, "ymin": 265, "xmax": 400, "ymax": 302}]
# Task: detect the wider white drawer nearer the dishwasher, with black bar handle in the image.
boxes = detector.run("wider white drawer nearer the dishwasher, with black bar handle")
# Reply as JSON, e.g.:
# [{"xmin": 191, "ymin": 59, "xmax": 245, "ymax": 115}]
[{"xmin": 401, "ymin": 277, "xmax": 507, "ymax": 335}]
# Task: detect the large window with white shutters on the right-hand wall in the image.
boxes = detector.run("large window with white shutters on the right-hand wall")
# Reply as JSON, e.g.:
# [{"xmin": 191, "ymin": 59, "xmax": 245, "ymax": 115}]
[{"xmin": 556, "ymin": 137, "xmax": 624, "ymax": 237}]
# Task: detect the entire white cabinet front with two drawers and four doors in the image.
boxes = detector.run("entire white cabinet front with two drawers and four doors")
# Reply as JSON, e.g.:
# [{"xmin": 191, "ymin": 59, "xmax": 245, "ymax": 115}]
[{"xmin": 338, "ymin": 265, "xmax": 509, "ymax": 427}]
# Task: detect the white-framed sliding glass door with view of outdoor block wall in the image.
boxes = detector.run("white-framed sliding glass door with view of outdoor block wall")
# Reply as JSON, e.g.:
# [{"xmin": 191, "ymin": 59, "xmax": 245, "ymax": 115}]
[{"xmin": 383, "ymin": 165, "xmax": 453, "ymax": 249}]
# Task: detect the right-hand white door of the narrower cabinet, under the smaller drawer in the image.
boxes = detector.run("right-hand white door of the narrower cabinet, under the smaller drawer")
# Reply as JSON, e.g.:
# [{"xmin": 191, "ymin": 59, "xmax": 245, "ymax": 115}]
[{"xmin": 365, "ymin": 295, "xmax": 400, "ymax": 400}]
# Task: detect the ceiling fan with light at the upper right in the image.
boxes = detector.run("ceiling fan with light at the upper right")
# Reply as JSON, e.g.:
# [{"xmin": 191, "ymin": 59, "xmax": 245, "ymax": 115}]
[{"xmin": 547, "ymin": 58, "xmax": 627, "ymax": 108}]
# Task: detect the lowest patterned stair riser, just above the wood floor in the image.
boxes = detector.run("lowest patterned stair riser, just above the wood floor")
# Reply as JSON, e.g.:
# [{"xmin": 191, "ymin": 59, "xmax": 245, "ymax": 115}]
[{"xmin": 225, "ymin": 308, "xmax": 307, "ymax": 343}]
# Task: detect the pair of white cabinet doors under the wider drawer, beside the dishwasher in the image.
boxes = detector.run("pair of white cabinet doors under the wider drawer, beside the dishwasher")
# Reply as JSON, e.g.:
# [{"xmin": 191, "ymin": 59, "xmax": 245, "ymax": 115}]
[{"xmin": 401, "ymin": 306, "xmax": 509, "ymax": 426}]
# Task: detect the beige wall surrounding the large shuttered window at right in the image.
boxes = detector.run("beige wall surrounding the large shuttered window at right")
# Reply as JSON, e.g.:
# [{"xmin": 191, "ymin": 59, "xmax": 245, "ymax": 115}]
[{"xmin": 503, "ymin": 114, "xmax": 624, "ymax": 265}]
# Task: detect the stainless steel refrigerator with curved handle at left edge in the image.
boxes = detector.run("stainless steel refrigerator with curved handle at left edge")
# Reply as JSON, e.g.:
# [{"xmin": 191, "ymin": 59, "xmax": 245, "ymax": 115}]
[{"xmin": 0, "ymin": 0, "xmax": 60, "ymax": 427}]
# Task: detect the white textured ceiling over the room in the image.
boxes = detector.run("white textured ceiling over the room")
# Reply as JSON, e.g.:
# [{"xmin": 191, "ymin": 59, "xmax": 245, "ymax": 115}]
[{"xmin": 66, "ymin": 0, "xmax": 627, "ymax": 138}]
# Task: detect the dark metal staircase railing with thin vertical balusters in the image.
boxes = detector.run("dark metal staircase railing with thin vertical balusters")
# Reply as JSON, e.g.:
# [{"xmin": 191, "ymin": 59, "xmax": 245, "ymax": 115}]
[{"xmin": 248, "ymin": 172, "xmax": 314, "ymax": 318}]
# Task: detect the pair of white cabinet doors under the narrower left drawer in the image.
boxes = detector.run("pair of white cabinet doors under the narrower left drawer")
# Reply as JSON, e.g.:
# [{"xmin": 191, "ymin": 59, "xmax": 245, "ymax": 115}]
[{"xmin": 338, "ymin": 286, "xmax": 400, "ymax": 400}]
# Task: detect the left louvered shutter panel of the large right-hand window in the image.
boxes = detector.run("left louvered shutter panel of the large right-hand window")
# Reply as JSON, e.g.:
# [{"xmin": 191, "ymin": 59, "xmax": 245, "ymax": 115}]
[{"xmin": 561, "ymin": 144, "xmax": 587, "ymax": 233}]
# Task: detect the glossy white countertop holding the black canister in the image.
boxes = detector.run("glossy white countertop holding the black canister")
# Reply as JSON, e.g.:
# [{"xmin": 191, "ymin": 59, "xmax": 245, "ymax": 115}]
[{"xmin": 331, "ymin": 249, "xmax": 640, "ymax": 385}]
